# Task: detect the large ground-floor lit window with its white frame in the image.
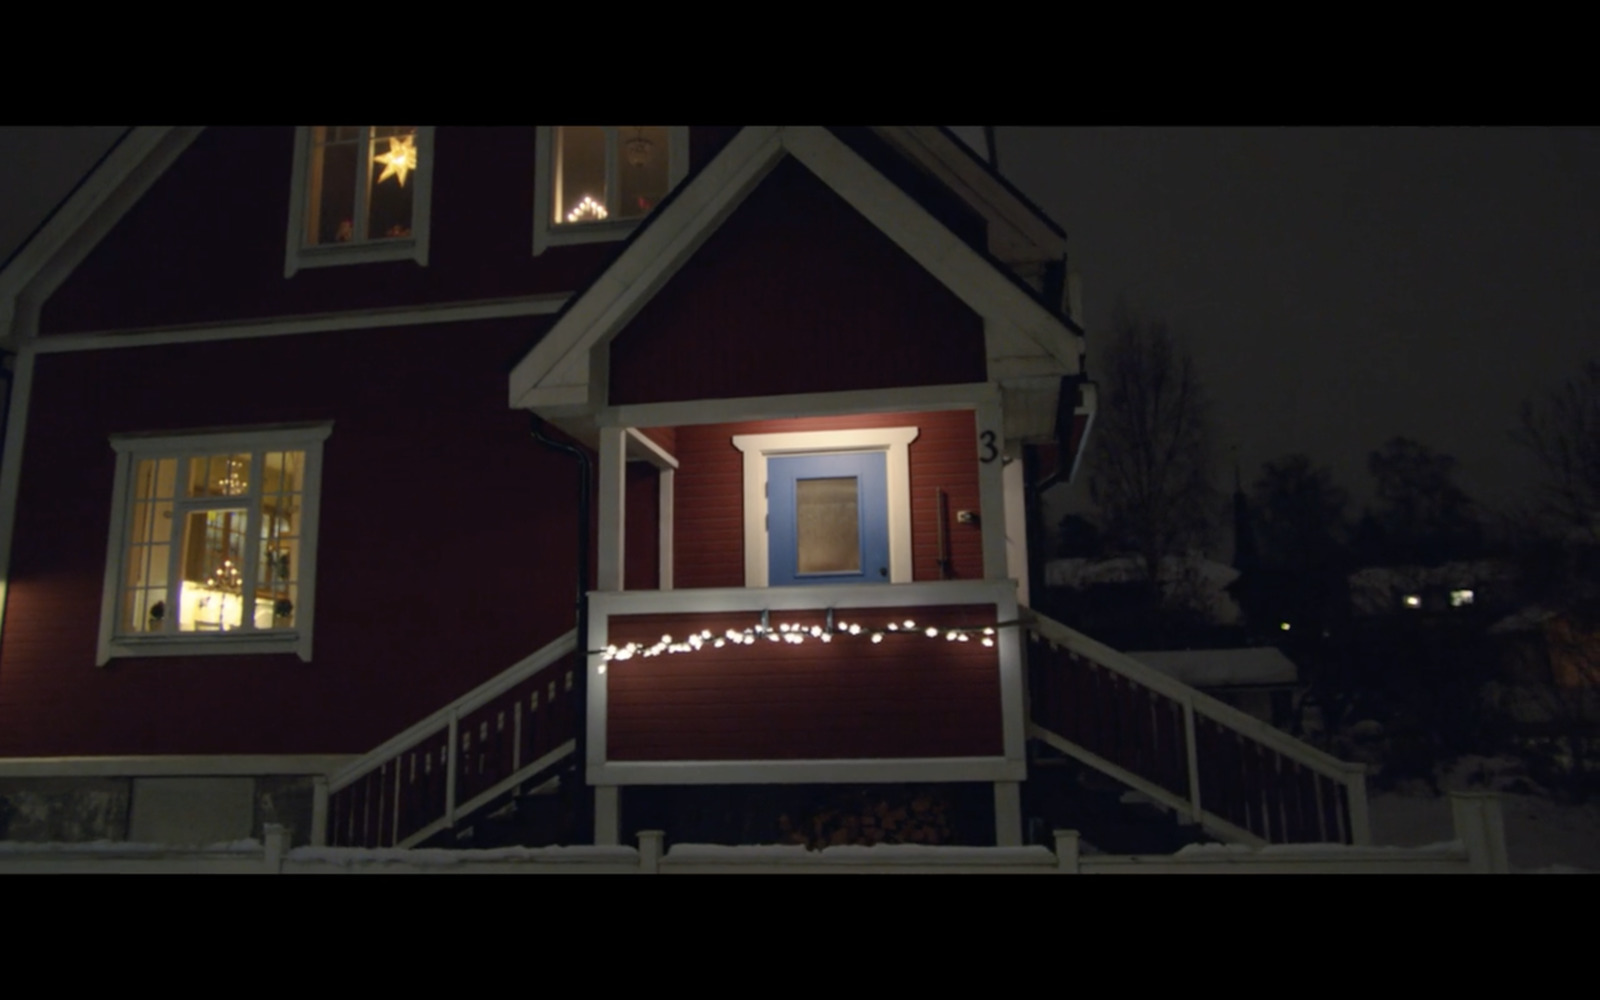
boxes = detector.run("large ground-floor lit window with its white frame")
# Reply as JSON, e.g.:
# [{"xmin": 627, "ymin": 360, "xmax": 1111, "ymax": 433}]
[{"xmin": 99, "ymin": 424, "xmax": 330, "ymax": 664}]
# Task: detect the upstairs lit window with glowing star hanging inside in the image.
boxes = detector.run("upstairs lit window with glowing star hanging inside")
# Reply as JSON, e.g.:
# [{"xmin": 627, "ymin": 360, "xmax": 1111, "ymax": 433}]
[{"xmin": 285, "ymin": 125, "xmax": 434, "ymax": 274}]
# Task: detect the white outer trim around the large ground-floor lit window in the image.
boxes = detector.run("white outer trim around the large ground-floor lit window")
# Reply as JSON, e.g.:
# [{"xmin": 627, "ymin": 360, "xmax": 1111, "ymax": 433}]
[{"xmin": 96, "ymin": 424, "xmax": 333, "ymax": 667}]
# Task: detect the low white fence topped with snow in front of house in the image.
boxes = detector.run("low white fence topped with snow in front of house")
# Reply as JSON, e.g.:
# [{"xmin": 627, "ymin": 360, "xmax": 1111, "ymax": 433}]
[{"xmin": 0, "ymin": 794, "xmax": 1509, "ymax": 875}]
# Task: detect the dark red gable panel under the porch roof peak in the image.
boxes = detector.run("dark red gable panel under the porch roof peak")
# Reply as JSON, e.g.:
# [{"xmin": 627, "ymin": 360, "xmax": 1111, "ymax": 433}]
[{"xmin": 610, "ymin": 160, "xmax": 987, "ymax": 403}]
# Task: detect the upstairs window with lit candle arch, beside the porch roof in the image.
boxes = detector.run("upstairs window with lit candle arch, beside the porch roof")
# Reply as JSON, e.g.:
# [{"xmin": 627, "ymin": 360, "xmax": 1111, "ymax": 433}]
[{"xmin": 533, "ymin": 125, "xmax": 688, "ymax": 253}]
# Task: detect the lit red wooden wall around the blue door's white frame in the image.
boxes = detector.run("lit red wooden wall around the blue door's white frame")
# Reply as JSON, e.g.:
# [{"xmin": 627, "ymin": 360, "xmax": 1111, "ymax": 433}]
[{"xmin": 672, "ymin": 410, "xmax": 984, "ymax": 587}]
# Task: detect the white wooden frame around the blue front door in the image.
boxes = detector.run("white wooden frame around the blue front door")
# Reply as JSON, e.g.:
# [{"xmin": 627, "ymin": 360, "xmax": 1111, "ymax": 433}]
[{"xmin": 733, "ymin": 427, "xmax": 918, "ymax": 587}]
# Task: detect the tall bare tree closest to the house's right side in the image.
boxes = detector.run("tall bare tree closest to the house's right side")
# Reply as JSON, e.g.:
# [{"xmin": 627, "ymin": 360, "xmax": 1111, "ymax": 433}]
[{"xmin": 1090, "ymin": 307, "xmax": 1218, "ymax": 592}]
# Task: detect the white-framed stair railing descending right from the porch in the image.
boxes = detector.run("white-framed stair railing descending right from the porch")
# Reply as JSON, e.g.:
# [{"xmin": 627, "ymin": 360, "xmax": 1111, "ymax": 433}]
[{"xmin": 1027, "ymin": 614, "xmax": 1371, "ymax": 845}]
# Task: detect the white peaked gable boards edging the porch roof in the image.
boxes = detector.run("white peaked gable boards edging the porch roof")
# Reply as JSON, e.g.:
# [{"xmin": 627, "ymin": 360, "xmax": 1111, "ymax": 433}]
[{"xmin": 510, "ymin": 125, "xmax": 1083, "ymax": 418}]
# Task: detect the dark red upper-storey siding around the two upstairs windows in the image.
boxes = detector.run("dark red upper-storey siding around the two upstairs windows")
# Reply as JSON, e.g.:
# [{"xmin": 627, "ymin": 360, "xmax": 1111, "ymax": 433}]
[{"xmin": 40, "ymin": 125, "xmax": 730, "ymax": 331}]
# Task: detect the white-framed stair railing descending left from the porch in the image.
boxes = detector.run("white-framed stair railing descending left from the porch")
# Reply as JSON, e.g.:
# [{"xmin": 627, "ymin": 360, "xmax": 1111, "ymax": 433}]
[{"xmin": 326, "ymin": 632, "xmax": 579, "ymax": 848}]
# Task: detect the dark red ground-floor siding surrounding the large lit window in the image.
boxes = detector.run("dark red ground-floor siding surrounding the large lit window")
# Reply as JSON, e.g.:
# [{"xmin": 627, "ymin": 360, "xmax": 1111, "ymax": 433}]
[{"xmin": 0, "ymin": 320, "xmax": 588, "ymax": 757}]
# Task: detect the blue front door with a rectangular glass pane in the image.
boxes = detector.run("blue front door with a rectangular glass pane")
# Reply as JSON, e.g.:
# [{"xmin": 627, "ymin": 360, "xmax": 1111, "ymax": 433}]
[{"xmin": 766, "ymin": 451, "xmax": 890, "ymax": 587}]
